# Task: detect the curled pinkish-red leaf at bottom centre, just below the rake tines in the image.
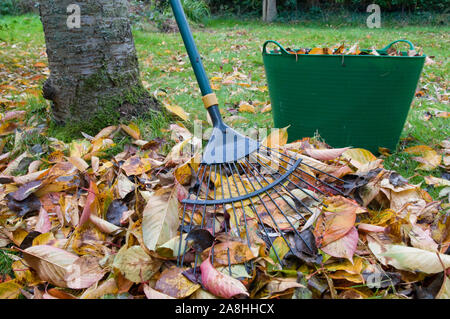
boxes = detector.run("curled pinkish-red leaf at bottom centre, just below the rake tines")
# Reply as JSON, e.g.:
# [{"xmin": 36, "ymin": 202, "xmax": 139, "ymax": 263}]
[{"xmin": 200, "ymin": 258, "xmax": 249, "ymax": 298}]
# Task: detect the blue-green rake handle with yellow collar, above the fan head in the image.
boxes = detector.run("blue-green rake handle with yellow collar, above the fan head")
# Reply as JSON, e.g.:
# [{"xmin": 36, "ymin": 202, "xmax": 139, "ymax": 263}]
[{"xmin": 170, "ymin": 0, "xmax": 223, "ymax": 126}]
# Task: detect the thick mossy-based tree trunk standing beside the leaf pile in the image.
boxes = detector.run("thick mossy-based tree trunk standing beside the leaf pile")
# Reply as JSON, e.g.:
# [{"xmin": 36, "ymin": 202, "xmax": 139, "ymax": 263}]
[{"xmin": 40, "ymin": 0, "xmax": 159, "ymax": 124}]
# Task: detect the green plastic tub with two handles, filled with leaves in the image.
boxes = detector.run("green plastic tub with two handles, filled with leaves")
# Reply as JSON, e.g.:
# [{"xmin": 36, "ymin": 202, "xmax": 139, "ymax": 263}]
[{"xmin": 263, "ymin": 40, "xmax": 425, "ymax": 153}]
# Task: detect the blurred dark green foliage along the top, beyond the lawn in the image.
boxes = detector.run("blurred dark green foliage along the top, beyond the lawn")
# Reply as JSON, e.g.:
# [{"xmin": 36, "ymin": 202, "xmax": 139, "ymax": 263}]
[{"xmin": 0, "ymin": 0, "xmax": 450, "ymax": 28}]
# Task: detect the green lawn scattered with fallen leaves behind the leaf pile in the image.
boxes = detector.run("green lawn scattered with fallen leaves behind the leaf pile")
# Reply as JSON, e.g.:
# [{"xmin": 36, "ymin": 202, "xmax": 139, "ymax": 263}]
[{"xmin": 0, "ymin": 15, "xmax": 450, "ymax": 274}]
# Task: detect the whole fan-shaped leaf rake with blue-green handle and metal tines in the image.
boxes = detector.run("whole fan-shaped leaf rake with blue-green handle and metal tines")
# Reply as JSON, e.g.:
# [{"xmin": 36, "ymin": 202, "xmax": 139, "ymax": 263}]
[{"xmin": 170, "ymin": 0, "xmax": 344, "ymax": 275}]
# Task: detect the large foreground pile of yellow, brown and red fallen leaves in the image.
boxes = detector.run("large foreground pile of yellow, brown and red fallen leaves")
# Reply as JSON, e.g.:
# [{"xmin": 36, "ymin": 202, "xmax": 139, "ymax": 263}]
[{"xmin": 0, "ymin": 122, "xmax": 450, "ymax": 299}]
